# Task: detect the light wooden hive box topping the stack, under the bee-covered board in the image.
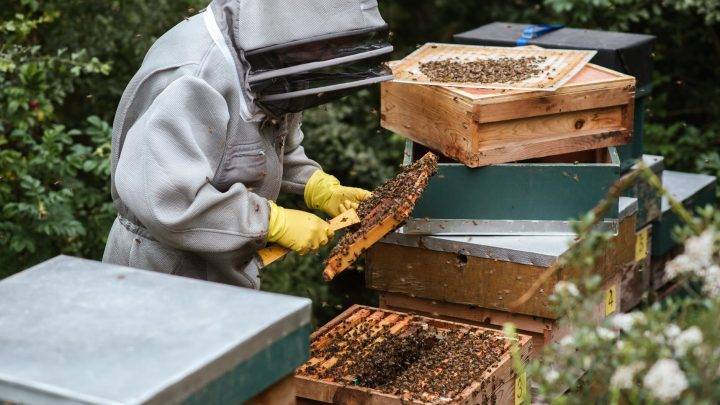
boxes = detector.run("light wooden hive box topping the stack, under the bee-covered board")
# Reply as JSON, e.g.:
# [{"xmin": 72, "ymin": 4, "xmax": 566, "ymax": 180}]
[{"xmin": 380, "ymin": 64, "xmax": 635, "ymax": 167}]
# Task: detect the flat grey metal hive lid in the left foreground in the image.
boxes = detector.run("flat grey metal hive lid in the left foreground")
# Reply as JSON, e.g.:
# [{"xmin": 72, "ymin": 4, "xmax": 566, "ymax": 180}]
[{"xmin": 0, "ymin": 256, "xmax": 310, "ymax": 404}]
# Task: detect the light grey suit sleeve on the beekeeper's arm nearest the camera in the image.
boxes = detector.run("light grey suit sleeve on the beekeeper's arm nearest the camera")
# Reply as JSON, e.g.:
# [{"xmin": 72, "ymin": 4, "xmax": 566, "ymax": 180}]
[{"xmin": 116, "ymin": 76, "xmax": 269, "ymax": 253}]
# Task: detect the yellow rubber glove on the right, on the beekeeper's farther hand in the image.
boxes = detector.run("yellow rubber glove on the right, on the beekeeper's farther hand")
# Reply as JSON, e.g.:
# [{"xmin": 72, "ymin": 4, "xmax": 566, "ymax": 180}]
[{"xmin": 305, "ymin": 170, "xmax": 372, "ymax": 217}]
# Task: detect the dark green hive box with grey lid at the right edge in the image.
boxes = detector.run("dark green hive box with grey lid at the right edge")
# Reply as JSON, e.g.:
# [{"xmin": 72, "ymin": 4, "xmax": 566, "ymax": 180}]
[{"xmin": 652, "ymin": 170, "xmax": 717, "ymax": 257}]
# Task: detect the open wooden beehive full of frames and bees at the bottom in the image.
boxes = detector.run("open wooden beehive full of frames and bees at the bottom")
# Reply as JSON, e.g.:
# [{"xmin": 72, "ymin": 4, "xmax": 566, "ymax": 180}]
[{"xmin": 296, "ymin": 305, "xmax": 532, "ymax": 404}]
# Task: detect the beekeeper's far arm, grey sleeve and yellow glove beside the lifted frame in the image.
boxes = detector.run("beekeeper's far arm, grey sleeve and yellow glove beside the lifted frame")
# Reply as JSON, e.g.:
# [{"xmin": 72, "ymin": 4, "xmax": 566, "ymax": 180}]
[{"xmin": 282, "ymin": 114, "xmax": 371, "ymax": 217}]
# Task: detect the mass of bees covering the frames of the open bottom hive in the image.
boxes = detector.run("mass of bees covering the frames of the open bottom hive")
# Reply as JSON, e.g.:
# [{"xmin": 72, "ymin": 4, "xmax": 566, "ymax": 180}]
[{"xmin": 299, "ymin": 317, "xmax": 507, "ymax": 402}]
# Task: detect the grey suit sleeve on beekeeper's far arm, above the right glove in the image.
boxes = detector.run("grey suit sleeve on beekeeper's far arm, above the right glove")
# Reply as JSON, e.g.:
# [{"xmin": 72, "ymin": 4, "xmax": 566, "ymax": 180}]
[{"xmin": 280, "ymin": 114, "xmax": 320, "ymax": 195}]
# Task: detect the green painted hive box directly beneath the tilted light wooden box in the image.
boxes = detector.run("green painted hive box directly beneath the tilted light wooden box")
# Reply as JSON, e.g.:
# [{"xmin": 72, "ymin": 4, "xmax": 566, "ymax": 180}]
[{"xmin": 403, "ymin": 142, "xmax": 620, "ymax": 235}]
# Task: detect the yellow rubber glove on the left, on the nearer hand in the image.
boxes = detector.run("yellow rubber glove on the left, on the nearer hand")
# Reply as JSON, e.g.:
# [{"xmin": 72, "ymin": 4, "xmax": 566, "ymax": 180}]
[{"xmin": 267, "ymin": 201, "xmax": 334, "ymax": 255}]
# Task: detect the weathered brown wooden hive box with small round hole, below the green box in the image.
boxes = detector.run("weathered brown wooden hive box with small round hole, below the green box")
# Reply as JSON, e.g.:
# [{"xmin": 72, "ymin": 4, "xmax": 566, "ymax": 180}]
[{"xmin": 365, "ymin": 215, "xmax": 636, "ymax": 319}]
